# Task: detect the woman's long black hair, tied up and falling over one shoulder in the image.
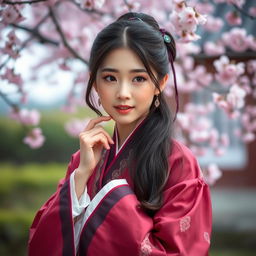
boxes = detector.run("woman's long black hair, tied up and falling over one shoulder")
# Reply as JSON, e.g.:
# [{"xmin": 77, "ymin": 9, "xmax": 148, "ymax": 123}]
[{"xmin": 86, "ymin": 12, "xmax": 176, "ymax": 216}]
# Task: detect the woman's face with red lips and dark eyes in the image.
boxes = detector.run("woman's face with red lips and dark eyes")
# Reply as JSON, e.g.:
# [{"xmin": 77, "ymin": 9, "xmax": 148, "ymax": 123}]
[{"xmin": 94, "ymin": 48, "xmax": 166, "ymax": 133}]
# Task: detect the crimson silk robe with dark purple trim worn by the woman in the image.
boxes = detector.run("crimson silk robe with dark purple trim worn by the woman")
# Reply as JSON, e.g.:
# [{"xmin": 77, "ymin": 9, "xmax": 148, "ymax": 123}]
[{"xmin": 29, "ymin": 122, "xmax": 212, "ymax": 256}]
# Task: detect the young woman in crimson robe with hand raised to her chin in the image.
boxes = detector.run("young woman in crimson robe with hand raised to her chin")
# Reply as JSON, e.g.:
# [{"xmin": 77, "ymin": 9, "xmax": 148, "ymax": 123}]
[{"xmin": 29, "ymin": 13, "xmax": 211, "ymax": 256}]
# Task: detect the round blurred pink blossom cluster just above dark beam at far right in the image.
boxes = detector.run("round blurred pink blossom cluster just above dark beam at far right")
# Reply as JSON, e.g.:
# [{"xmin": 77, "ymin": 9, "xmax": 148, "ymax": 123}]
[{"xmin": 222, "ymin": 28, "xmax": 250, "ymax": 52}]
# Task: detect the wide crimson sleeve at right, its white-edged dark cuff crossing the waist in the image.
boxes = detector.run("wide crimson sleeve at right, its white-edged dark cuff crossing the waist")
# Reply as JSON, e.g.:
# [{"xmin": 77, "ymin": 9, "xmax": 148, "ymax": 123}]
[{"xmin": 79, "ymin": 142, "xmax": 212, "ymax": 256}]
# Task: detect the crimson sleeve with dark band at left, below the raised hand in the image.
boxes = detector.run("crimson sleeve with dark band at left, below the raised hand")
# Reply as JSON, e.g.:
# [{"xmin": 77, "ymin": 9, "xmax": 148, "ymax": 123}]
[{"xmin": 28, "ymin": 151, "xmax": 79, "ymax": 256}]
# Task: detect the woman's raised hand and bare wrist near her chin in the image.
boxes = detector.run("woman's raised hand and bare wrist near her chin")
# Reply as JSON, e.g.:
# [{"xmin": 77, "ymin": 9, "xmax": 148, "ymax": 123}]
[{"xmin": 75, "ymin": 116, "xmax": 114, "ymax": 198}]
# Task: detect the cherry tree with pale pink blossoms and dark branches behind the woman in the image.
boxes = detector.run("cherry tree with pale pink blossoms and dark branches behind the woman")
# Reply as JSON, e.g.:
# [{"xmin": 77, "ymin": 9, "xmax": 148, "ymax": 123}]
[{"xmin": 0, "ymin": 0, "xmax": 256, "ymax": 184}]
